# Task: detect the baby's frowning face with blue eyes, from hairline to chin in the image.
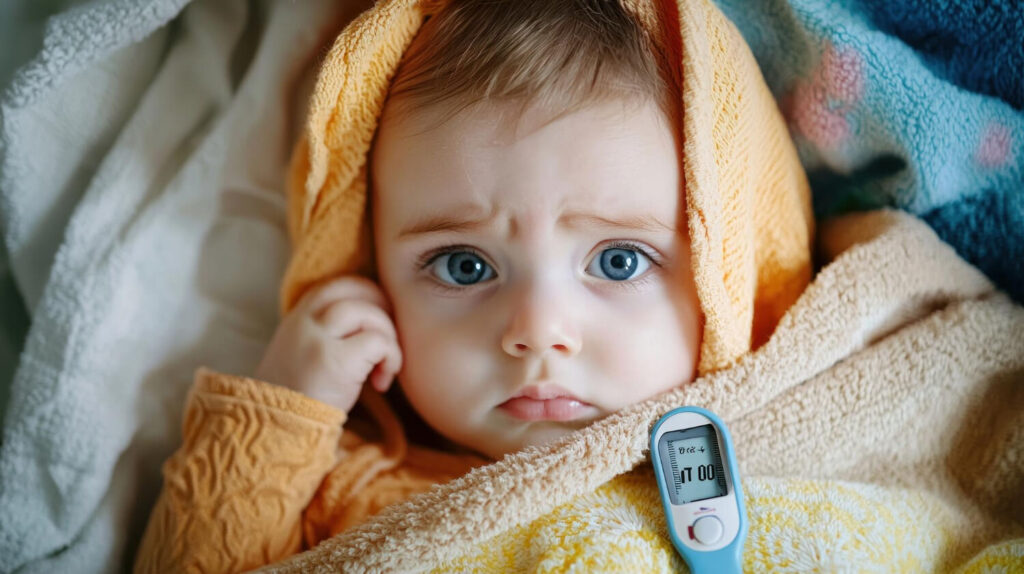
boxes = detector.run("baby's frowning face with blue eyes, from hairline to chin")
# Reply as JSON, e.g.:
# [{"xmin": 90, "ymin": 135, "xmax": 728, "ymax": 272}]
[{"xmin": 373, "ymin": 101, "xmax": 701, "ymax": 457}]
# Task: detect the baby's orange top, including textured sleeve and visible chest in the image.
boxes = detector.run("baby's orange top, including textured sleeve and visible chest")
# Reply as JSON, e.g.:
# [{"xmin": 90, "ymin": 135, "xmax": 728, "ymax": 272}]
[{"xmin": 135, "ymin": 369, "xmax": 484, "ymax": 573}]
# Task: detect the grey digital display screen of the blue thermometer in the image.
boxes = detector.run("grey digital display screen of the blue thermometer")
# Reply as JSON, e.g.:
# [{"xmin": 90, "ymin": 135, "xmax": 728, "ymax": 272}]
[{"xmin": 657, "ymin": 425, "xmax": 726, "ymax": 504}]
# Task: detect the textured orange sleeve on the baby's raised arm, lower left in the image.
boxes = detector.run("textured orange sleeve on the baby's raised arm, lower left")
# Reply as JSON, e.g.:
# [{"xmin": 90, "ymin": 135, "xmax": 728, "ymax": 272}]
[{"xmin": 135, "ymin": 369, "xmax": 346, "ymax": 572}]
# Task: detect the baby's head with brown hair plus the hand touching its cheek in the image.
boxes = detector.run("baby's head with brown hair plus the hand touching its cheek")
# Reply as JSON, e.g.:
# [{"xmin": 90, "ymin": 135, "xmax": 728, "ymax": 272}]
[{"xmin": 256, "ymin": 2, "xmax": 700, "ymax": 457}]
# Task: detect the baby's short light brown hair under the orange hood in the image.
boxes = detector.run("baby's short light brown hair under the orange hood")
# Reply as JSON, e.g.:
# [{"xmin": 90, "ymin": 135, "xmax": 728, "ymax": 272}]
[{"xmin": 390, "ymin": 0, "xmax": 679, "ymax": 124}]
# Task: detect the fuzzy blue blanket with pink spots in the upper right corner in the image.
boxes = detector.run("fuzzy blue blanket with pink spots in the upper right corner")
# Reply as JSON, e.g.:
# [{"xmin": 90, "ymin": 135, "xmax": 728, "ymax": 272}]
[{"xmin": 717, "ymin": 0, "xmax": 1024, "ymax": 302}]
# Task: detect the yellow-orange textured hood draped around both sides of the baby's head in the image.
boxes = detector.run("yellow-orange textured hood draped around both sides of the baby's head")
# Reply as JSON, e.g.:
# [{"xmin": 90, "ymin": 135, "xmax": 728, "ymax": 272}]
[{"xmin": 282, "ymin": 0, "xmax": 813, "ymax": 372}]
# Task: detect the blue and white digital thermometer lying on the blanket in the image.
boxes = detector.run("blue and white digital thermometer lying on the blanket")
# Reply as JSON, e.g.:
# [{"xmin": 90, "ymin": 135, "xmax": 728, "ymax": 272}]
[{"xmin": 650, "ymin": 406, "xmax": 746, "ymax": 574}]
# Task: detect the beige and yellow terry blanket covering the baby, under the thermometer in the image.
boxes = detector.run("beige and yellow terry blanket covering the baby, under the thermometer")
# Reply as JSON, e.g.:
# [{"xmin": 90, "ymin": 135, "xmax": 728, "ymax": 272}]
[{"xmin": 263, "ymin": 211, "xmax": 1024, "ymax": 574}]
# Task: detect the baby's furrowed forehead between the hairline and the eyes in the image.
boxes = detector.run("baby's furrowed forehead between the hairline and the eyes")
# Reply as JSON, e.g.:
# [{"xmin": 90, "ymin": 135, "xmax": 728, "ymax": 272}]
[{"xmin": 373, "ymin": 97, "xmax": 680, "ymax": 236}]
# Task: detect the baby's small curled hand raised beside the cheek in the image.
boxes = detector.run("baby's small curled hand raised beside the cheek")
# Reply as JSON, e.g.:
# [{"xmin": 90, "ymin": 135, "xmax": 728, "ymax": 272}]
[{"xmin": 256, "ymin": 276, "xmax": 401, "ymax": 412}]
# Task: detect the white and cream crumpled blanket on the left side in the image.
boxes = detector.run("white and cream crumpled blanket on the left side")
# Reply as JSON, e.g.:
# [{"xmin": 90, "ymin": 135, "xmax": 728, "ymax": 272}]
[{"xmin": 0, "ymin": 0, "xmax": 365, "ymax": 572}]
